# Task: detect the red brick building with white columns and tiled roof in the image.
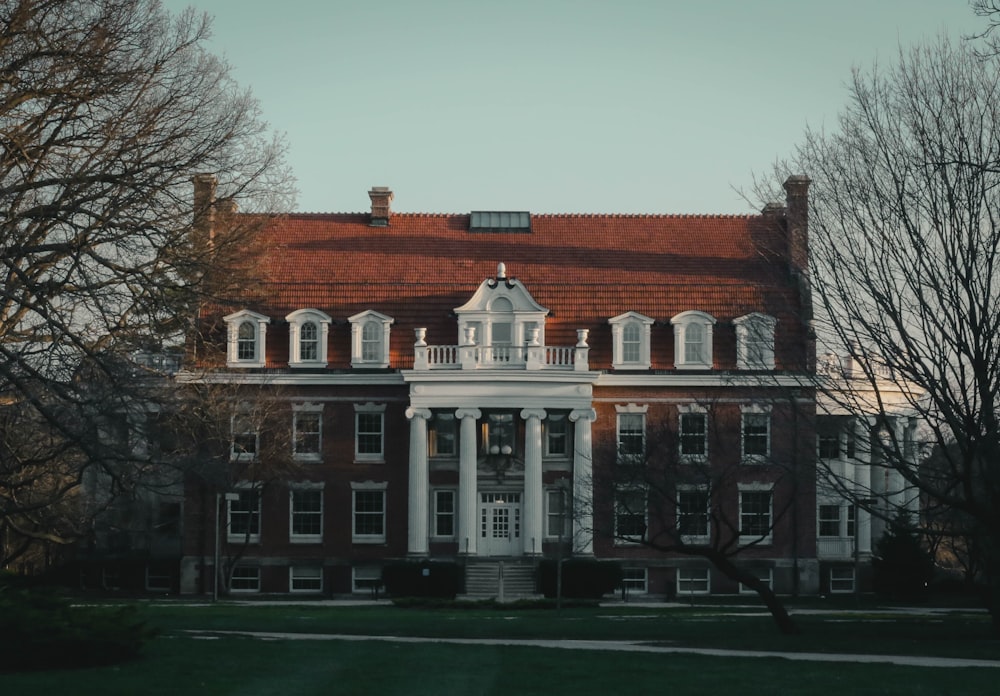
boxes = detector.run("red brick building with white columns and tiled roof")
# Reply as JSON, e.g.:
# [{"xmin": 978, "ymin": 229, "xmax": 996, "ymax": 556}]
[{"xmin": 180, "ymin": 177, "xmax": 820, "ymax": 595}]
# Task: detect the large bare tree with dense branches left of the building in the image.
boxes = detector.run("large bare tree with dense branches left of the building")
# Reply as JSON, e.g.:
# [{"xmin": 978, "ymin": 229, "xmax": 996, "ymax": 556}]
[{"xmin": 0, "ymin": 0, "xmax": 290, "ymax": 564}]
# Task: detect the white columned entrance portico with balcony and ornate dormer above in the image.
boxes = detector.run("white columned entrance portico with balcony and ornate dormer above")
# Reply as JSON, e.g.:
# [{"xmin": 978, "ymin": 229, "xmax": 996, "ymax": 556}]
[{"xmin": 403, "ymin": 264, "xmax": 598, "ymax": 557}]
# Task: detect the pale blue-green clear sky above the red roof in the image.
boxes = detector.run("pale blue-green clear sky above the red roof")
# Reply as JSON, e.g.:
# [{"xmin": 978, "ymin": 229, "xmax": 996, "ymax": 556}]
[{"xmin": 163, "ymin": 0, "xmax": 983, "ymax": 213}]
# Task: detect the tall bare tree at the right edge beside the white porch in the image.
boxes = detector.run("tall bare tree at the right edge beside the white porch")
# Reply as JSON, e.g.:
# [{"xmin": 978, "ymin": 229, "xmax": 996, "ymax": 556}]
[{"xmin": 776, "ymin": 39, "xmax": 1000, "ymax": 631}]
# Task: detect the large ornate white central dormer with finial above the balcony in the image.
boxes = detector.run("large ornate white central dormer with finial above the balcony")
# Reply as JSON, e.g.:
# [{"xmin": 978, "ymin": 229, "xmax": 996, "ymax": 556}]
[{"xmin": 455, "ymin": 263, "xmax": 549, "ymax": 353}]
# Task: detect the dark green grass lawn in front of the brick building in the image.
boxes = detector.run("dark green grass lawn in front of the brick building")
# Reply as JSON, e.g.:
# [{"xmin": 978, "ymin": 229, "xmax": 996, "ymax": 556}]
[{"xmin": 0, "ymin": 603, "xmax": 1000, "ymax": 696}]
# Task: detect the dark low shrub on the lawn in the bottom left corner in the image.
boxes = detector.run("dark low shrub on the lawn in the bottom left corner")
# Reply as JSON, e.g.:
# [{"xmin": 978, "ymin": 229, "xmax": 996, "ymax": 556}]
[{"xmin": 0, "ymin": 576, "xmax": 154, "ymax": 671}]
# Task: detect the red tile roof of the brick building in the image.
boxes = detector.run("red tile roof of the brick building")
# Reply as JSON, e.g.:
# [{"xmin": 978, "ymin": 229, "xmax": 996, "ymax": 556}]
[{"xmin": 209, "ymin": 214, "xmax": 803, "ymax": 369}]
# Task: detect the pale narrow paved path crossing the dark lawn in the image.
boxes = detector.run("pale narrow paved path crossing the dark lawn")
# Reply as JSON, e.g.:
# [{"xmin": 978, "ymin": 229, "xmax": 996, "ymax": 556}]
[{"xmin": 188, "ymin": 631, "xmax": 1000, "ymax": 668}]
